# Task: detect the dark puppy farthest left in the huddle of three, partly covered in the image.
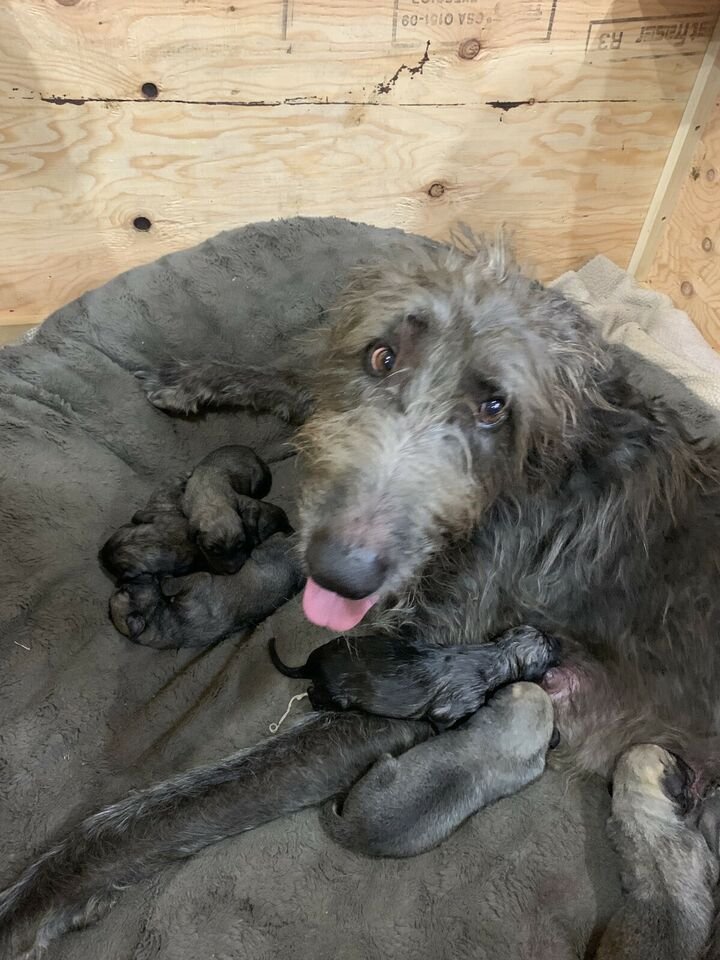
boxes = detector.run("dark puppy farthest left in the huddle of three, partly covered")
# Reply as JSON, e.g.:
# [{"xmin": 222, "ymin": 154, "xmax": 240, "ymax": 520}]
[{"xmin": 100, "ymin": 476, "xmax": 197, "ymax": 580}]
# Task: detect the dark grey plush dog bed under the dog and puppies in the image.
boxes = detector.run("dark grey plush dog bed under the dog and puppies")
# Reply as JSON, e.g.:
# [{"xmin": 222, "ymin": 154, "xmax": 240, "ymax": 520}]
[{"xmin": 0, "ymin": 219, "xmax": 618, "ymax": 960}]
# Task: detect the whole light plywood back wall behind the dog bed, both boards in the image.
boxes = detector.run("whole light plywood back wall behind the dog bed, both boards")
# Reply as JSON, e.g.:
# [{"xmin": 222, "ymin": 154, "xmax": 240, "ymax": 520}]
[{"xmin": 0, "ymin": 0, "xmax": 717, "ymax": 325}]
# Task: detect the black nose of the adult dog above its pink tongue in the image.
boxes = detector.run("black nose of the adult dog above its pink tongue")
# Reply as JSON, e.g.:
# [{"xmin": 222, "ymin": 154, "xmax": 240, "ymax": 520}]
[{"xmin": 305, "ymin": 530, "xmax": 387, "ymax": 600}]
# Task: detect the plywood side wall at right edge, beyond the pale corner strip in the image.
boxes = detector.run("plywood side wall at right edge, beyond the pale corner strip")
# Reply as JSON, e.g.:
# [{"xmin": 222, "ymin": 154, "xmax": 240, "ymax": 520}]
[{"xmin": 647, "ymin": 101, "xmax": 720, "ymax": 350}]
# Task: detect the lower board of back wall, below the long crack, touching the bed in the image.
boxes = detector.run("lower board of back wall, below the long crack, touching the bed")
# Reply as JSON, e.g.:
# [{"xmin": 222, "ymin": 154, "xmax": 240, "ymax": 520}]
[{"xmin": 0, "ymin": 101, "xmax": 682, "ymax": 324}]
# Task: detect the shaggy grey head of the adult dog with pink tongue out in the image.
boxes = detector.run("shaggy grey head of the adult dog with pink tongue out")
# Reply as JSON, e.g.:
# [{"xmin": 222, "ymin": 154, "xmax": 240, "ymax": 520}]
[{"xmin": 299, "ymin": 240, "xmax": 602, "ymax": 630}]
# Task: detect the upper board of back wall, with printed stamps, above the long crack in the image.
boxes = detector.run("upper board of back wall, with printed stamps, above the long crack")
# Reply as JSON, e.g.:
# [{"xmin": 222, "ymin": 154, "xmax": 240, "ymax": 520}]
[{"xmin": 0, "ymin": 0, "xmax": 717, "ymax": 105}]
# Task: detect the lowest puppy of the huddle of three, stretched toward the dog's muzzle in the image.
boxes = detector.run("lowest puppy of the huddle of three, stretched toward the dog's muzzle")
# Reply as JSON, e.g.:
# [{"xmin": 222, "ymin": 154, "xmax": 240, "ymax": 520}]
[{"xmin": 110, "ymin": 534, "xmax": 304, "ymax": 649}]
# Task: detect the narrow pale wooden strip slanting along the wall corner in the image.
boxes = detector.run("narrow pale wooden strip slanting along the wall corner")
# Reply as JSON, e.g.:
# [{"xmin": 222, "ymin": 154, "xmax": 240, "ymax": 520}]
[{"xmin": 628, "ymin": 18, "xmax": 720, "ymax": 280}]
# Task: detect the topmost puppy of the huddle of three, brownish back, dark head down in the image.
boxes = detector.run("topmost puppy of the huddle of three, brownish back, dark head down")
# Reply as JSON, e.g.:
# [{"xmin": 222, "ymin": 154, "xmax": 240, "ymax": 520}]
[{"xmin": 182, "ymin": 446, "xmax": 291, "ymax": 573}]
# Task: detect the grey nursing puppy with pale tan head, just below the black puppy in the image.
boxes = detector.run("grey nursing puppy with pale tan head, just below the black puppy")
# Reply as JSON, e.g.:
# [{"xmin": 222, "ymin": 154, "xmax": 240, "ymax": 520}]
[{"xmin": 322, "ymin": 683, "xmax": 553, "ymax": 857}]
